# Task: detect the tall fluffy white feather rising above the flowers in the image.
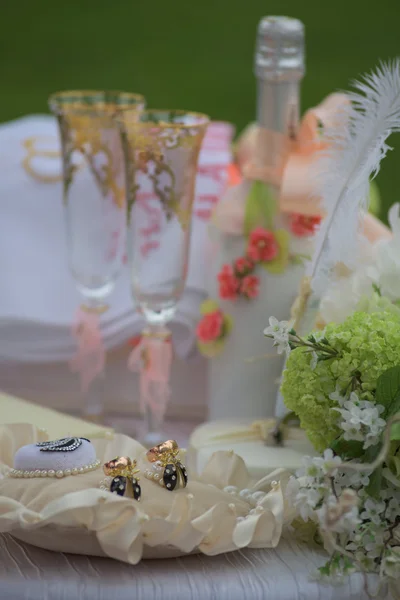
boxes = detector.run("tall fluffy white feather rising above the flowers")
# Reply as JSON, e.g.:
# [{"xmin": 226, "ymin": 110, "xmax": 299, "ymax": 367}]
[{"xmin": 308, "ymin": 59, "xmax": 400, "ymax": 296}]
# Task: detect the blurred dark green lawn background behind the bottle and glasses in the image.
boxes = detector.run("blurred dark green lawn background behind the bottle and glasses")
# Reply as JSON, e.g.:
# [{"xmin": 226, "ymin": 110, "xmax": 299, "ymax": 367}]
[{"xmin": 0, "ymin": 0, "xmax": 400, "ymax": 218}]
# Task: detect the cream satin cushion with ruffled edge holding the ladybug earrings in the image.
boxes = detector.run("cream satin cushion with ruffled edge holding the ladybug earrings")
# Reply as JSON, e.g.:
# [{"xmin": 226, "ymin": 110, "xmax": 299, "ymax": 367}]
[{"xmin": 0, "ymin": 424, "xmax": 292, "ymax": 564}]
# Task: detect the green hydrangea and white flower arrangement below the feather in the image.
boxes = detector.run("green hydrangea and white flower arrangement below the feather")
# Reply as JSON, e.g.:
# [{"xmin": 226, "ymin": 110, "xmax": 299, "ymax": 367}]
[{"xmin": 264, "ymin": 311, "xmax": 400, "ymax": 583}]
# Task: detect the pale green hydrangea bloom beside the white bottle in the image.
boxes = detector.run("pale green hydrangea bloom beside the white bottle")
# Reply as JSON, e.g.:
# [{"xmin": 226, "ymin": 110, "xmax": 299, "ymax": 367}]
[{"xmin": 282, "ymin": 312, "xmax": 400, "ymax": 452}]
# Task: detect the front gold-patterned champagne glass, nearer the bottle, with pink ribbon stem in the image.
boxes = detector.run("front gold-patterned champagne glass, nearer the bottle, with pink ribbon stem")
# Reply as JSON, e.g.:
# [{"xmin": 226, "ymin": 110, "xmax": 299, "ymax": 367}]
[{"xmin": 118, "ymin": 110, "xmax": 209, "ymax": 446}]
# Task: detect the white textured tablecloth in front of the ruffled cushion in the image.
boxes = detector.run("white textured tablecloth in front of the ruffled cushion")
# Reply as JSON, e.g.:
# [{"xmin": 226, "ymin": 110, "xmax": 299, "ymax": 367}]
[{"xmin": 0, "ymin": 418, "xmax": 390, "ymax": 600}]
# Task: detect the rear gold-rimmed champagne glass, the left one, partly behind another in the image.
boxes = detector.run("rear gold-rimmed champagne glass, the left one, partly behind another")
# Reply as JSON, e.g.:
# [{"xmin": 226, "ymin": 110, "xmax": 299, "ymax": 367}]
[{"xmin": 49, "ymin": 90, "xmax": 145, "ymax": 418}]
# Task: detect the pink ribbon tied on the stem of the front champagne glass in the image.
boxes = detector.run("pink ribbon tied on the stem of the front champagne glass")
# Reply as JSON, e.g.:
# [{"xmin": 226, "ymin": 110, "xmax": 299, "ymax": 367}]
[{"xmin": 128, "ymin": 332, "xmax": 172, "ymax": 422}]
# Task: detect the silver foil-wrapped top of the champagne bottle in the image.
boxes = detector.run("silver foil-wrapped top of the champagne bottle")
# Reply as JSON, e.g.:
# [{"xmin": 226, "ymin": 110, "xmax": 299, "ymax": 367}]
[{"xmin": 255, "ymin": 17, "xmax": 305, "ymax": 81}]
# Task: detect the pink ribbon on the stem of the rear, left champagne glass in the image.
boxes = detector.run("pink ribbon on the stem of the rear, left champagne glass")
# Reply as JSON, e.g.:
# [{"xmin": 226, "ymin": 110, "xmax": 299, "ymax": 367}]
[{"xmin": 69, "ymin": 308, "xmax": 106, "ymax": 393}]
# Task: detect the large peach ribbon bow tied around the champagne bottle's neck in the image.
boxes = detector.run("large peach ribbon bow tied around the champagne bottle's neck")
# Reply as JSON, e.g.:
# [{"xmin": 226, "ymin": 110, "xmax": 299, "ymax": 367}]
[{"xmin": 213, "ymin": 94, "xmax": 390, "ymax": 242}]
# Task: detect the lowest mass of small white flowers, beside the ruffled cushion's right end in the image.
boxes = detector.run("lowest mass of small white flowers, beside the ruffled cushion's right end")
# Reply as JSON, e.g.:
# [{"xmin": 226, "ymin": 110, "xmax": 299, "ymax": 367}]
[{"xmin": 286, "ymin": 448, "xmax": 400, "ymax": 578}]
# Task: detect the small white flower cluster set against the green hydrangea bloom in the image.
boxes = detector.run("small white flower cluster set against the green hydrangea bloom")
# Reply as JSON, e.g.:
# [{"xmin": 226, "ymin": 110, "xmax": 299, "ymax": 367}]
[{"xmin": 330, "ymin": 392, "xmax": 386, "ymax": 450}]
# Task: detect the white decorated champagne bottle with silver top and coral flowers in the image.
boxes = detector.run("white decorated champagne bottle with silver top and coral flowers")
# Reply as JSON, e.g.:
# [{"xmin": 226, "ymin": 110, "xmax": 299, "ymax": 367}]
[{"xmin": 209, "ymin": 17, "xmax": 310, "ymax": 420}]
